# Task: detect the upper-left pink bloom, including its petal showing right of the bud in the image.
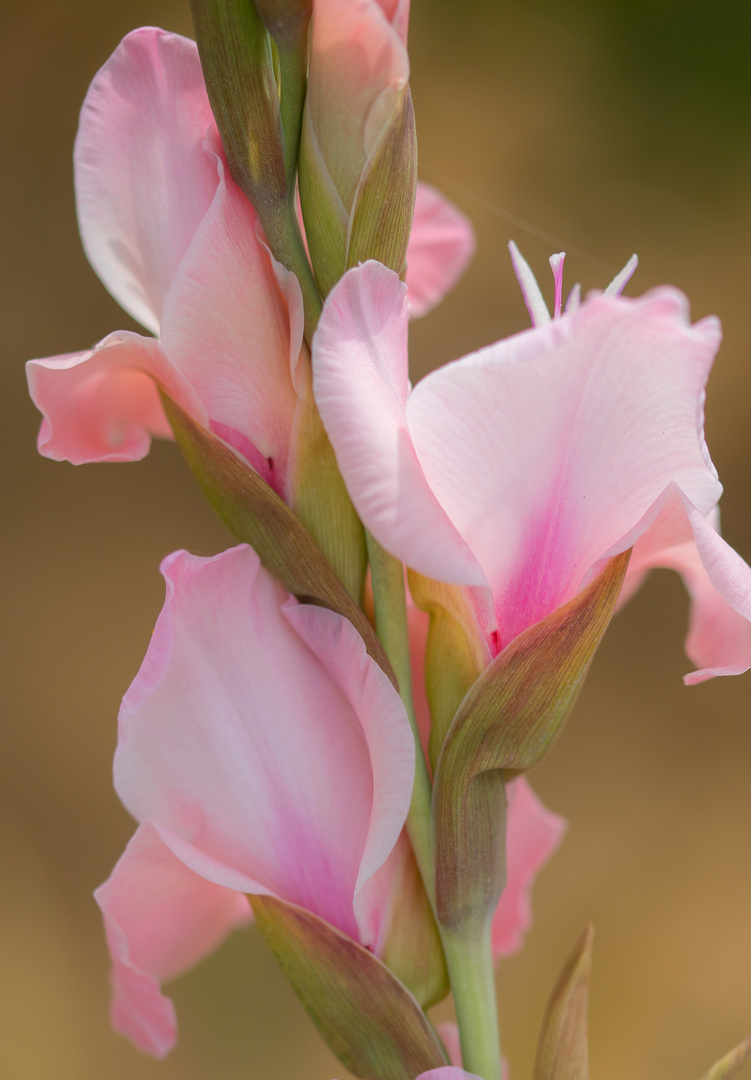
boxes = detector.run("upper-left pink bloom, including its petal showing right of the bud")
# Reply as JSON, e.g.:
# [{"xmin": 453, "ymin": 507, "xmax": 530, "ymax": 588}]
[{"xmin": 27, "ymin": 28, "xmax": 472, "ymax": 477}]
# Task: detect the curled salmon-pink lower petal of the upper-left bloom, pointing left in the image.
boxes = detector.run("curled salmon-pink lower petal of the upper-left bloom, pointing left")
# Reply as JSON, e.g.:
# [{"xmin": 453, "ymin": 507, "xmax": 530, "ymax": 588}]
[{"xmin": 26, "ymin": 330, "xmax": 205, "ymax": 464}]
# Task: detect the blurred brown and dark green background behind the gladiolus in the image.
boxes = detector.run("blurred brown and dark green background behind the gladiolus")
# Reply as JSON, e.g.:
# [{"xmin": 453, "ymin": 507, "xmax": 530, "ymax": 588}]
[{"xmin": 0, "ymin": 0, "xmax": 751, "ymax": 1080}]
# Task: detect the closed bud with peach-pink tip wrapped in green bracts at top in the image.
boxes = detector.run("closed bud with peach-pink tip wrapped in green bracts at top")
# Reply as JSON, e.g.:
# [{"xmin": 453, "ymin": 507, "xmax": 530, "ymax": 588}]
[{"xmin": 299, "ymin": 0, "xmax": 417, "ymax": 295}]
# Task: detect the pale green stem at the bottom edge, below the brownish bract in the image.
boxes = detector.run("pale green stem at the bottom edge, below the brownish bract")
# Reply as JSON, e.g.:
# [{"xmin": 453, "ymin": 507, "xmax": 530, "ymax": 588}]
[{"xmin": 441, "ymin": 924, "xmax": 501, "ymax": 1080}]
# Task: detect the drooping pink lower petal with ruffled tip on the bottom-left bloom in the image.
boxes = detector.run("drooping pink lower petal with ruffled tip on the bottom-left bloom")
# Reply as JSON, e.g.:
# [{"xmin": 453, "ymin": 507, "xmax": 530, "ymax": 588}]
[{"xmin": 94, "ymin": 822, "xmax": 251, "ymax": 1057}]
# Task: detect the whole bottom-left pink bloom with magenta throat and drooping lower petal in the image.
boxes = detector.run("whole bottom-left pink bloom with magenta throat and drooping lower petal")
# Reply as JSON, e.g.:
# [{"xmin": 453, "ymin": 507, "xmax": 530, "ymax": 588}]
[{"xmin": 96, "ymin": 546, "xmax": 414, "ymax": 1056}]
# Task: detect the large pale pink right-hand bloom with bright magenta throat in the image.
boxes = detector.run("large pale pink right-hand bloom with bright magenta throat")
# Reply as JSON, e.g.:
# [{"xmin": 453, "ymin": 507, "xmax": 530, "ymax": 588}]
[{"xmin": 313, "ymin": 261, "xmax": 751, "ymax": 681}]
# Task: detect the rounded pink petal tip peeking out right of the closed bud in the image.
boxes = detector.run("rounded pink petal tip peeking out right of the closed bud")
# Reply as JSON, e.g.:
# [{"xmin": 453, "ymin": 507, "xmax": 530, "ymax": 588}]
[{"xmin": 406, "ymin": 184, "xmax": 474, "ymax": 319}]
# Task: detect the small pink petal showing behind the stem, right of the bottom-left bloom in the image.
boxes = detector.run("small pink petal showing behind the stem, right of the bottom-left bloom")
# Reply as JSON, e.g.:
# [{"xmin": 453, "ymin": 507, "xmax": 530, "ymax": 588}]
[{"xmin": 492, "ymin": 777, "xmax": 566, "ymax": 960}]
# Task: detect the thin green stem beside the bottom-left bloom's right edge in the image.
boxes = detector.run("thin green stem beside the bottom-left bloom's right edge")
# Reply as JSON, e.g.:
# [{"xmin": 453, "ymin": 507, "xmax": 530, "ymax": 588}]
[{"xmin": 365, "ymin": 531, "xmax": 435, "ymax": 908}]
